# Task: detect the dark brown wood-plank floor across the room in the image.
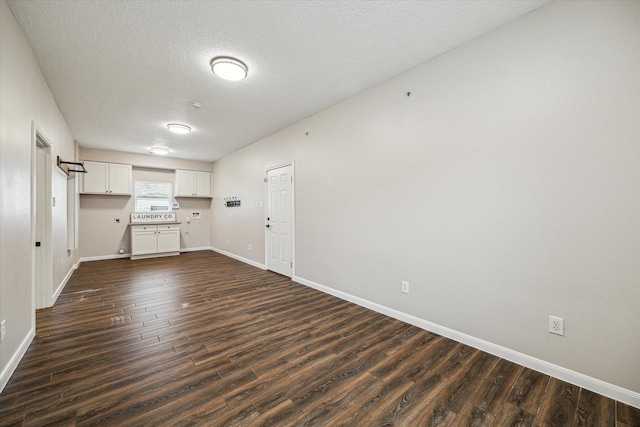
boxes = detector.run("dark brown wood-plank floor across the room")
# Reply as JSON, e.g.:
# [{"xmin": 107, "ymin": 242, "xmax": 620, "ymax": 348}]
[{"xmin": 0, "ymin": 251, "xmax": 640, "ymax": 426}]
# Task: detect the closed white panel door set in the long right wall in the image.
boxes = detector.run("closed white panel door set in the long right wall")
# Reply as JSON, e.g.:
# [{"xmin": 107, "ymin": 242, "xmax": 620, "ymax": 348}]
[{"xmin": 266, "ymin": 165, "xmax": 293, "ymax": 277}]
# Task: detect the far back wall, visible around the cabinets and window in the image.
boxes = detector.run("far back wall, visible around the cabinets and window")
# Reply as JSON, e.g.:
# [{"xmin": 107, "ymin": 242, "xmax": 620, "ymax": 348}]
[{"xmin": 79, "ymin": 148, "xmax": 212, "ymax": 260}]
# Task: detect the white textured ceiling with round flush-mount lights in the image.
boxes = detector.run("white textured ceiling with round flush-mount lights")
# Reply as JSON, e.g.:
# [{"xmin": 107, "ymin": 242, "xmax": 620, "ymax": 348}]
[{"xmin": 9, "ymin": 0, "xmax": 546, "ymax": 161}]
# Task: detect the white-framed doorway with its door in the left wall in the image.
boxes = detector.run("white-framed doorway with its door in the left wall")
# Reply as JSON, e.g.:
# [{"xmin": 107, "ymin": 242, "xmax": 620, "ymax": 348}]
[{"xmin": 31, "ymin": 121, "xmax": 53, "ymax": 310}]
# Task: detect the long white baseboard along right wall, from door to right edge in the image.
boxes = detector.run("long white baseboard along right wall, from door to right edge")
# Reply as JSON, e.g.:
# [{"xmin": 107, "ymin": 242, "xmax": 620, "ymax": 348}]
[{"xmin": 293, "ymin": 276, "xmax": 640, "ymax": 408}]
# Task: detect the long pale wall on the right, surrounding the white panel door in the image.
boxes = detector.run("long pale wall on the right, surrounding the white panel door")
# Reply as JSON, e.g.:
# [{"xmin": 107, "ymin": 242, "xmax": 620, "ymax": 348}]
[{"xmin": 212, "ymin": 1, "xmax": 640, "ymax": 406}]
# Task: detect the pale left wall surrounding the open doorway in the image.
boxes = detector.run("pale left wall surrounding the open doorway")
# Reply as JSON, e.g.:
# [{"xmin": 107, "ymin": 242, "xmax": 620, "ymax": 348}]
[{"xmin": 0, "ymin": 0, "xmax": 77, "ymax": 389}]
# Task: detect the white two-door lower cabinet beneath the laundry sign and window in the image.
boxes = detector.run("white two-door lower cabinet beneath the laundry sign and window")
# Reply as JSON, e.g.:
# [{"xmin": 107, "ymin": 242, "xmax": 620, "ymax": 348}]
[{"xmin": 131, "ymin": 224, "xmax": 180, "ymax": 259}]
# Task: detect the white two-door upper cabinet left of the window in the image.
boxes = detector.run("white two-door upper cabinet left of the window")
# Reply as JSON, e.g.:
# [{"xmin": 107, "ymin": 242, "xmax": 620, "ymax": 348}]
[{"xmin": 82, "ymin": 161, "xmax": 133, "ymax": 195}]
